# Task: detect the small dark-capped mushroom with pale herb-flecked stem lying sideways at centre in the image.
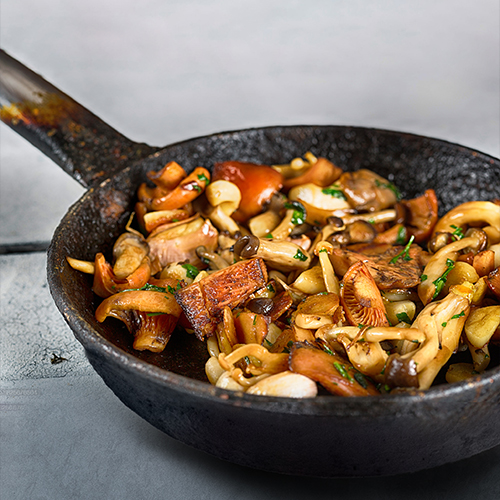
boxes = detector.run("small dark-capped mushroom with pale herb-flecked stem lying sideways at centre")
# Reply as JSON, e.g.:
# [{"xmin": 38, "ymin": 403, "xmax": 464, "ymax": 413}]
[{"xmin": 234, "ymin": 235, "xmax": 311, "ymax": 272}]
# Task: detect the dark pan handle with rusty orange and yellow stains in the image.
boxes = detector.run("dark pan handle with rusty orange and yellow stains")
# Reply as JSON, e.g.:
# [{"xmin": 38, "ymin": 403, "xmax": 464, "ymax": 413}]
[{"xmin": 0, "ymin": 50, "xmax": 159, "ymax": 188}]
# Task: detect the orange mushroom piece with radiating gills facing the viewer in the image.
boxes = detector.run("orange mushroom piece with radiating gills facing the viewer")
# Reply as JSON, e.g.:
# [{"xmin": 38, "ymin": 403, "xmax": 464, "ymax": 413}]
[{"xmin": 340, "ymin": 261, "xmax": 389, "ymax": 326}]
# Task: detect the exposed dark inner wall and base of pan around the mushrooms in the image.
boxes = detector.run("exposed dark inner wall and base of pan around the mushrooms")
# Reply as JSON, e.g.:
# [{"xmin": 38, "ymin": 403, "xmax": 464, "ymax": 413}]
[{"xmin": 48, "ymin": 126, "xmax": 500, "ymax": 380}]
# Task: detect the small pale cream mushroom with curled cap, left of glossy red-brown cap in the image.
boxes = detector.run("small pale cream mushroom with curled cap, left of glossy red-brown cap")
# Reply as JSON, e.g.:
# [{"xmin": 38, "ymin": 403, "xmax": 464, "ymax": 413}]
[{"xmin": 205, "ymin": 180, "xmax": 241, "ymax": 234}]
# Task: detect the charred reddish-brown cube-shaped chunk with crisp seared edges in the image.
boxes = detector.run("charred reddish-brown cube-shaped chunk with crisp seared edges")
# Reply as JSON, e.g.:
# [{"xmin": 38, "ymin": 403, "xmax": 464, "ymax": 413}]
[{"xmin": 175, "ymin": 258, "xmax": 267, "ymax": 340}]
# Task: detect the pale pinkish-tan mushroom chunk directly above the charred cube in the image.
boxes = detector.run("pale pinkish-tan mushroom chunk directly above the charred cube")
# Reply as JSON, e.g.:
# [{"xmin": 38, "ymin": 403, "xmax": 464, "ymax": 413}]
[{"xmin": 147, "ymin": 215, "xmax": 218, "ymax": 267}]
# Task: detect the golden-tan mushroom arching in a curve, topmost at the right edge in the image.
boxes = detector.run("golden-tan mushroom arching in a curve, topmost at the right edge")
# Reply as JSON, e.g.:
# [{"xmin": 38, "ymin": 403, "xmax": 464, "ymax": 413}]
[{"xmin": 433, "ymin": 201, "xmax": 500, "ymax": 234}]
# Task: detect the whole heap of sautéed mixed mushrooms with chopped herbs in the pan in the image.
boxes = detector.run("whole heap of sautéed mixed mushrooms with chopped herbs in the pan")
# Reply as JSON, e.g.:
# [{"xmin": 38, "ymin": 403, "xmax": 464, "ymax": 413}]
[{"xmin": 68, "ymin": 153, "xmax": 500, "ymax": 398}]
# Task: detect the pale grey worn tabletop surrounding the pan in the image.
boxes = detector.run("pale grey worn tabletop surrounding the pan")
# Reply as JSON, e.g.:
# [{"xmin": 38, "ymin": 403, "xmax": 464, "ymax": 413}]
[{"xmin": 0, "ymin": 0, "xmax": 500, "ymax": 500}]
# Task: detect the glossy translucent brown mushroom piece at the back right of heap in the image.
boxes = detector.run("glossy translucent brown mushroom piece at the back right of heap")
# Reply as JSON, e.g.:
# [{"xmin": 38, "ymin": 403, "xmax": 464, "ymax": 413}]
[{"xmin": 339, "ymin": 168, "xmax": 399, "ymax": 212}]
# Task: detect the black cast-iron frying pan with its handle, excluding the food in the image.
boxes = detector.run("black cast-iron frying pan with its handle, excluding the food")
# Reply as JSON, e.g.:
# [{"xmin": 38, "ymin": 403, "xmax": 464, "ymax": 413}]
[{"xmin": 0, "ymin": 51, "xmax": 500, "ymax": 477}]
